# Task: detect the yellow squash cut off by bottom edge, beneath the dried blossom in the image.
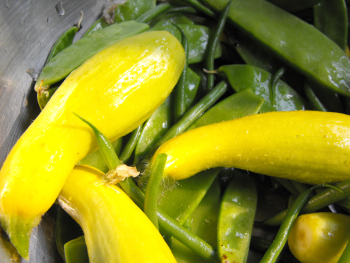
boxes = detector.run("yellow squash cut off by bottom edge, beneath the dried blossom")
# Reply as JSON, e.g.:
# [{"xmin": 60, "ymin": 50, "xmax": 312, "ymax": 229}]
[{"xmin": 58, "ymin": 165, "xmax": 176, "ymax": 263}]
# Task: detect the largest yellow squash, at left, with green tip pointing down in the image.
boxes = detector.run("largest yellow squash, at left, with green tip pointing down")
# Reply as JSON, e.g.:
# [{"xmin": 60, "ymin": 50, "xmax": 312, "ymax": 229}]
[{"xmin": 0, "ymin": 31, "xmax": 185, "ymax": 258}]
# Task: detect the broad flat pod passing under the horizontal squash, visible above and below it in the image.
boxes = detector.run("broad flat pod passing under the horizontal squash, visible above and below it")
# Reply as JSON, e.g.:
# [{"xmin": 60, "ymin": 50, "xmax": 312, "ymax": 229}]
[{"xmin": 159, "ymin": 89, "xmax": 263, "ymax": 228}]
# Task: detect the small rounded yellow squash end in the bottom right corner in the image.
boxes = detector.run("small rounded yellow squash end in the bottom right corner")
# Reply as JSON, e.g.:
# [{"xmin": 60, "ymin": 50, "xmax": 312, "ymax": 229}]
[{"xmin": 288, "ymin": 213, "xmax": 350, "ymax": 263}]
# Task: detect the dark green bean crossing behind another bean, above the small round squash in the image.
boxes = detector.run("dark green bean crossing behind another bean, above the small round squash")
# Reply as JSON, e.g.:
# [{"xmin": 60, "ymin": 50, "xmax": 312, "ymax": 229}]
[{"xmin": 263, "ymin": 180, "xmax": 350, "ymax": 226}]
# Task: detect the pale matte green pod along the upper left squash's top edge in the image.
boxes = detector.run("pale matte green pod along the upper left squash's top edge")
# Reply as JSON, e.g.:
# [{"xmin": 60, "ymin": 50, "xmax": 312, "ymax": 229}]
[{"xmin": 35, "ymin": 21, "xmax": 148, "ymax": 90}]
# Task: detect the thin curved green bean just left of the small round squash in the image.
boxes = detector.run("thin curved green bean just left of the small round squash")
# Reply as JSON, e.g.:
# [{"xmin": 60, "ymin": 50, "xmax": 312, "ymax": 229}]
[{"xmin": 260, "ymin": 185, "xmax": 323, "ymax": 263}]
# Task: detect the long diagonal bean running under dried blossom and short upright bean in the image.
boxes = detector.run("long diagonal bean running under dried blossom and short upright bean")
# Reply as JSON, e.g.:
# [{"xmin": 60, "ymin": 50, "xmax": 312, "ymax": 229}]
[{"xmin": 81, "ymin": 118, "xmax": 218, "ymax": 262}]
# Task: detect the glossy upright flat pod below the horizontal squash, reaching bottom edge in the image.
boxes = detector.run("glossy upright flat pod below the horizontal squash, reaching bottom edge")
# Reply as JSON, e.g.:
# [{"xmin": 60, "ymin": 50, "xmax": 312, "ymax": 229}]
[{"xmin": 218, "ymin": 171, "xmax": 257, "ymax": 263}]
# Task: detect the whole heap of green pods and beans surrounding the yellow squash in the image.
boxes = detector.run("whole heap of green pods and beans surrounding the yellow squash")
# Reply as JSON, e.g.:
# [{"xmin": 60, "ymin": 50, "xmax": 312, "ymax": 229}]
[{"xmin": 5, "ymin": 0, "xmax": 350, "ymax": 263}]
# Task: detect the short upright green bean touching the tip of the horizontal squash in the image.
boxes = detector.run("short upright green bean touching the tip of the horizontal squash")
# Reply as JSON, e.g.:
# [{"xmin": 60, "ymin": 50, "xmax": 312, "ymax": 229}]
[{"xmin": 143, "ymin": 153, "xmax": 167, "ymax": 229}]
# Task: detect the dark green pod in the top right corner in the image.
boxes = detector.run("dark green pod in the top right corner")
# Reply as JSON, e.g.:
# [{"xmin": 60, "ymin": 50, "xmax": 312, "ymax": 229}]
[{"xmin": 314, "ymin": 0, "xmax": 348, "ymax": 51}]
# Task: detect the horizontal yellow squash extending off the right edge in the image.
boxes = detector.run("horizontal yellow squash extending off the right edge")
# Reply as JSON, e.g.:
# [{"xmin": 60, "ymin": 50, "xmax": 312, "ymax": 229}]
[{"xmin": 151, "ymin": 111, "xmax": 350, "ymax": 184}]
